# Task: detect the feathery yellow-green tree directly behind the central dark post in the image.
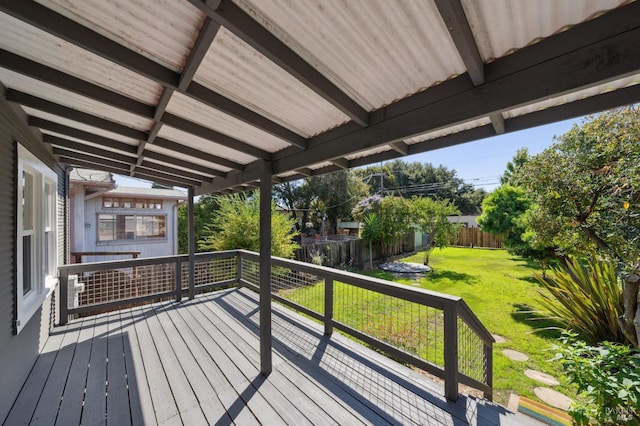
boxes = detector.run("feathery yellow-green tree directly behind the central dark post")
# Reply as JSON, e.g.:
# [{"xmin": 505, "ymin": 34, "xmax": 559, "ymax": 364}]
[{"xmin": 198, "ymin": 191, "xmax": 298, "ymax": 258}]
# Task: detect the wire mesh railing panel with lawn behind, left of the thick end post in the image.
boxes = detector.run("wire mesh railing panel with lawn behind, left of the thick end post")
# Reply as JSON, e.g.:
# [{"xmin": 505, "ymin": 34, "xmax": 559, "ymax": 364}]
[{"xmin": 333, "ymin": 282, "xmax": 444, "ymax": 366}]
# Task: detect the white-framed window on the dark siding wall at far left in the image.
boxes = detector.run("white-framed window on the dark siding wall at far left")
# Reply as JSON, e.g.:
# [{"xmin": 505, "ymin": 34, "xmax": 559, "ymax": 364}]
[{"xmin": 15, "ymin": 144, "xmax": 58, "ymax": 333}]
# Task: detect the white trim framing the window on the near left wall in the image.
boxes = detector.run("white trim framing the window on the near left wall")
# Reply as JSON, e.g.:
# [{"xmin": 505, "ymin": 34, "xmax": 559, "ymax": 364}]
[{"xmin": 15, "ymin": 144, "xmax": 58, "ymax": 333}]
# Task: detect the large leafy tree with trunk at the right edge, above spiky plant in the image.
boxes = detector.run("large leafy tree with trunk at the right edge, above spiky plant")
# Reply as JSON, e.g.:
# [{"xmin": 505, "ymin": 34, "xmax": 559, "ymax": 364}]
[{"xmin": 516, "ymin": 107, "xmax": 640, "ymax": 347}]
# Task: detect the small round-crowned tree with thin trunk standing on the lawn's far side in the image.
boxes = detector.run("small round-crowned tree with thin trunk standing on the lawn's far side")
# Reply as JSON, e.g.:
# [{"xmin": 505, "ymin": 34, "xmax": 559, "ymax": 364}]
[{"xmin": 411, "ymin": 197, "xmax": 460, "ymax": 265}]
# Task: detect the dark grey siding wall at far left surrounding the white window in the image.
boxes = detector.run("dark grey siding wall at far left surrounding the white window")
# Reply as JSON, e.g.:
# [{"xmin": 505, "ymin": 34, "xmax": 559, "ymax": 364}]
[{"xmin": 0, "ymin": 86, "xmax": 66, "ymax": 424}]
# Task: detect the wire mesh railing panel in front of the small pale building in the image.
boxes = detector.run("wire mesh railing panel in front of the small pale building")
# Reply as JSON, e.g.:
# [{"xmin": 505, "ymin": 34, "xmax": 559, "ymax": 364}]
[{"xmin": 76, "ymin": 262, "xmax": 175, "ymax": 308}]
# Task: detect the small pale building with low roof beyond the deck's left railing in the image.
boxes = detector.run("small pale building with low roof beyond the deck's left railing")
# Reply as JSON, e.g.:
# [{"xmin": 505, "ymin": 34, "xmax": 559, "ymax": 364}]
[{"xmin": 69, "ymin": 169, "xmax": 187, "ymax": 262}]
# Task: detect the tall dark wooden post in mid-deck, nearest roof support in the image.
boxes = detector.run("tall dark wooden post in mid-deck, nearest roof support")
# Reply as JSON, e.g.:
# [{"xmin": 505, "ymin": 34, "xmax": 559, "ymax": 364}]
[{"xmin": 260, "ymin": 161, "xmax": 272, "ymax": 376}]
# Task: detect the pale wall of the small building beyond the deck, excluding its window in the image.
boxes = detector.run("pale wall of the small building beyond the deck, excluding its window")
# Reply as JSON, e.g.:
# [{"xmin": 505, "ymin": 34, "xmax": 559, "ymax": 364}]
[{"xmin": 79, "ymin": 197, "xmax": 178, "ymax": 263}]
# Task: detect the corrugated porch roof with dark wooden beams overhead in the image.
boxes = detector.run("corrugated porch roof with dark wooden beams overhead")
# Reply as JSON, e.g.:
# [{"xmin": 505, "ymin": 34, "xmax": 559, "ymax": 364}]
[{"xmin": 0, "ymin": 0, "xmax": 640, "ymax": 194}]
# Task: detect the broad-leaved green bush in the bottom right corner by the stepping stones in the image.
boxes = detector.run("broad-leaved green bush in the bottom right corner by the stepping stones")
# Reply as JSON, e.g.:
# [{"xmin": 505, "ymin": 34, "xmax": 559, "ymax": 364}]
[{"xmin": 555, "ymin": 333, "xmax": 640, "ymax": 425}]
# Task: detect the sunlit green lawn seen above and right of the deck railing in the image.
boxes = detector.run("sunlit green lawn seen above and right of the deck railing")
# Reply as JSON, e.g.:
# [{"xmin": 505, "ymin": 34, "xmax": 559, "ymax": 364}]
[{"xmin": 384, "ymin": 247, "xmax": 575, "ymax": 404}]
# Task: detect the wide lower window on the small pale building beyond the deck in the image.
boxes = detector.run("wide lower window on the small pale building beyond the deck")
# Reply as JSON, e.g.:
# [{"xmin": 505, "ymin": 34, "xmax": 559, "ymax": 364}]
[{"xmin": 98, "ymin": 214, "xmax": 167, "ymax": 241}]
